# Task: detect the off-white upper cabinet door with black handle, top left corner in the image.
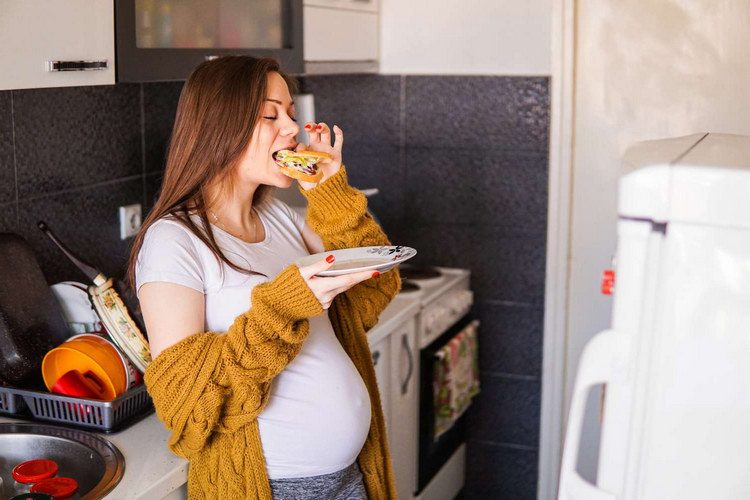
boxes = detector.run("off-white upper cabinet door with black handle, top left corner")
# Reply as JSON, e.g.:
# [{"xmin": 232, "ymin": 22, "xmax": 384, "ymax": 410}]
[{"xmin": 0, "ymin": 0, "xmax": 115, "ymax": 90}]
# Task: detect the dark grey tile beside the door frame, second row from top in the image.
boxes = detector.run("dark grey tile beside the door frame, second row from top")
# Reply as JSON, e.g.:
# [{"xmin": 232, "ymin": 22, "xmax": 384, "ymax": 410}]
[{"xmin": 405, "ymin": 148, "xmax": 548, "ymax": 229}]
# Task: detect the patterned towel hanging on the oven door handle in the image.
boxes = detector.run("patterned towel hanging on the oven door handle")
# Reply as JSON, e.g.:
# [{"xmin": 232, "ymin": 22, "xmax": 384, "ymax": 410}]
[{"xmin": 432, "ymin": 320, "xmax": 479, "ymax": 441}]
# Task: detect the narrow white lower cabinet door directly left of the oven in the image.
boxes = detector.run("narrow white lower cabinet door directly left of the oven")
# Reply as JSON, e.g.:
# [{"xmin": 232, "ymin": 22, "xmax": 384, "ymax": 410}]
[{"xmin": 390, "ymin": 320, "xmax": 419, "ymax": 500}]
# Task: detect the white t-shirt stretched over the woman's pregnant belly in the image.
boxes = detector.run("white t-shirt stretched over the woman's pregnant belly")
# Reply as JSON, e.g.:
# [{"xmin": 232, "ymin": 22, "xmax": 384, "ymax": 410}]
[{"xmin": 136, "ymin": 199, "xmax": 371, "ymax": 479}]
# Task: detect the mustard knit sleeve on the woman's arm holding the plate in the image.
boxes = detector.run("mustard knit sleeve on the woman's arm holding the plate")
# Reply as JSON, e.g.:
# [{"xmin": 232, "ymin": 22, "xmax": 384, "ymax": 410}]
[{"xmin": 144, "ymin": 266, "xmax": 323, "ymax": 458}]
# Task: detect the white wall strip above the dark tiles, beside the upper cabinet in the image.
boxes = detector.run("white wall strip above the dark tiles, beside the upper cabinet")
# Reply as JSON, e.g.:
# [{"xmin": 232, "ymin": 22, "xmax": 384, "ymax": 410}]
[{"xmin": 380, "ymin": 0, "xmax": 552, "ymax": 75}]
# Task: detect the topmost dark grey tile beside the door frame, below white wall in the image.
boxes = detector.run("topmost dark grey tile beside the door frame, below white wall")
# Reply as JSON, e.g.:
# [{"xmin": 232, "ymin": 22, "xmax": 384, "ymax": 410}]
[{"xmin": 406, "ymin": 76, "xmax": 550, "ymax": 152}]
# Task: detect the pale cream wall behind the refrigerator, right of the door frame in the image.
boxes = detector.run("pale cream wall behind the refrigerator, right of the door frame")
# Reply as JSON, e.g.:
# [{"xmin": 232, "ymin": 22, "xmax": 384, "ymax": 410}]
[{"xmin": 565, "ymin": 0, "xmax": 750, "ymax": 484}]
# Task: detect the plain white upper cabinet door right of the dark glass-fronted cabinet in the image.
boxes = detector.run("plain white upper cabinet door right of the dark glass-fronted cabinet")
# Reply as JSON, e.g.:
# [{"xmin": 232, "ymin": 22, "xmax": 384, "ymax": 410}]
[{"xmin": 304, "ymin": 5, "xmax": 378, "ymax": 61}]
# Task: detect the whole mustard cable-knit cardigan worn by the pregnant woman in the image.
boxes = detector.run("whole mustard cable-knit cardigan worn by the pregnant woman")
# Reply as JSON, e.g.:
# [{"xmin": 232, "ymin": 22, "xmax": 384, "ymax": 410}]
[{"xmin": 144, "ymin": 167, "xmax": 400, "ymax": 500}]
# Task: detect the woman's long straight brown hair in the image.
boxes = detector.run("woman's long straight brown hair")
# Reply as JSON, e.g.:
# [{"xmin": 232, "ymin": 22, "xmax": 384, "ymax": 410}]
[{"xmin": 127, "ymin": 56, "xmax": 298, "ymax": 288}]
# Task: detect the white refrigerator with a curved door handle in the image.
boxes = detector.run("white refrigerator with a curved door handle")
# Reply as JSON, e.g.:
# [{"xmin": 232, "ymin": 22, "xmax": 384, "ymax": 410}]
[{"xmin": 558, "ymin": 133, "xmax": 750, "ymax": 500}]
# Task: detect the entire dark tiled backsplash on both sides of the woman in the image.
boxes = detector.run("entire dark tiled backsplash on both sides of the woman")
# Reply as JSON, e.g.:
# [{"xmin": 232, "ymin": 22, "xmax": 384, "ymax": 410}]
[{"xmin": 0, "ymin": 75, "xmax": 549, "ymax": 500}]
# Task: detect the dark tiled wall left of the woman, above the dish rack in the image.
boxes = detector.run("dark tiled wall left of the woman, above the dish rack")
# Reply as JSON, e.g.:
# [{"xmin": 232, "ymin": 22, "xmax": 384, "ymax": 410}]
[{"xmin": 0, "ymin": 83, "xmax": 182, "ymax": 283}]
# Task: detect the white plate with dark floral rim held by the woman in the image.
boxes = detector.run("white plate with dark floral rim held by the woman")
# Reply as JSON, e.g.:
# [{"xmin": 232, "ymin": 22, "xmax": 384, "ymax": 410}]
[{"xmin": 294, "ymin": 246, "xmax": 417, "ymax": 277}]
